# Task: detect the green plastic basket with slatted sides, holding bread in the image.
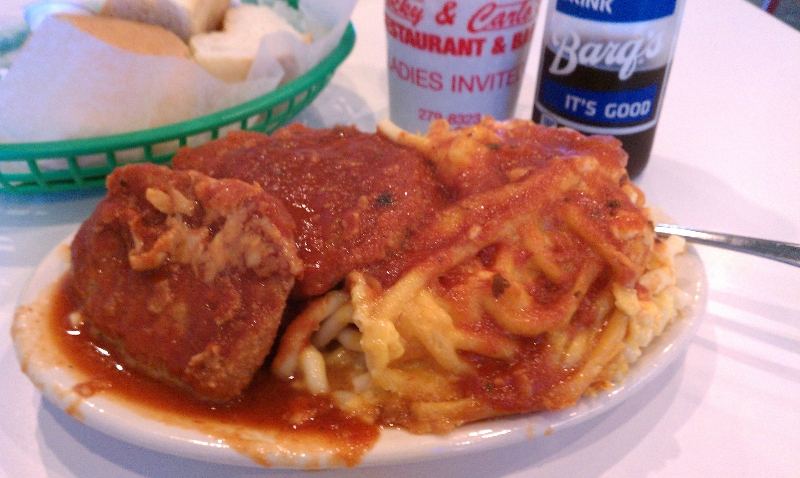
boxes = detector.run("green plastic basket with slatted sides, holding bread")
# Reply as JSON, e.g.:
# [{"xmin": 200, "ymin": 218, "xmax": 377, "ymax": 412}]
[{"xmin": 0, "ymin": 19, "xmax": 356, "ymax": 194}]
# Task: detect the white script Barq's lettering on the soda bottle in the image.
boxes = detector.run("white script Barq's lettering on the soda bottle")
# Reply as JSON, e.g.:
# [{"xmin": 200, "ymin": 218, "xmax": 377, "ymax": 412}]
[{"xmin": 547, "ymin": 31, "xmax": 664, "ymax": 81}]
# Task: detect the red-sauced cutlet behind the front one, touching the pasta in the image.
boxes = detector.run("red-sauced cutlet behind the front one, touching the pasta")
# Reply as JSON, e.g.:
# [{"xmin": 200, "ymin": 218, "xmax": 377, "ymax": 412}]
[{"xmin": 173, "ymin": 124, "xmax": 445, "ymax": 297}]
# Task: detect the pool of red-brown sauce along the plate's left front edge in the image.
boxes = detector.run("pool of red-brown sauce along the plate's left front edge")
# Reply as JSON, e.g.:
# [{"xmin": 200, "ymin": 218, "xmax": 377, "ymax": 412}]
[{"xmin": 48, "ymin": 274, "xmax": 380, "ymax": 468}]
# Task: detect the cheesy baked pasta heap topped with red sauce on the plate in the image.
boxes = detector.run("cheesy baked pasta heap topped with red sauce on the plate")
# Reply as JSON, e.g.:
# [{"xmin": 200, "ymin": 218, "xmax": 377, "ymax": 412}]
[{"xmin": 271, "ymin": 118, "xmax": 685, "ymax": 433}]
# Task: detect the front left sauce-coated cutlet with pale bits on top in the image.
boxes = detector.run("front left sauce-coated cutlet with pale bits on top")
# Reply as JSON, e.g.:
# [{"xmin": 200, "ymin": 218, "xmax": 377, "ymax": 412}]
[{"xmin": 71, "ymin": 164, "xmax": 302, "ymax": 402}]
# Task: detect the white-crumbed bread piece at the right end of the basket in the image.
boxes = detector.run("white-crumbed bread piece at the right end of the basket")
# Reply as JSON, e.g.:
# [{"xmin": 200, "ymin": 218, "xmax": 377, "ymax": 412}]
[{"xmin": 189, "ymin": 4, "xmax": 311, "ymax": 83}]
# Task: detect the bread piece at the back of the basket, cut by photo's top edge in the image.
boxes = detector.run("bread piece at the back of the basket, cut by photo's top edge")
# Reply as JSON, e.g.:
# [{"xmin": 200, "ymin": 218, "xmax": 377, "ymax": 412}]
[{"xmin": 100, "ymin": 0, "xmax": 230, "ymax": 41}]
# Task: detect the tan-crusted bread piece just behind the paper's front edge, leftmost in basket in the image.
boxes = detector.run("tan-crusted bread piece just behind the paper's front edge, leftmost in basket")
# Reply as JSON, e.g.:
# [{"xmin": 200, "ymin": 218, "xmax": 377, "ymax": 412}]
[{"xmin": 59, "ymin": 14, "xmax": 191, "ymax": 58}]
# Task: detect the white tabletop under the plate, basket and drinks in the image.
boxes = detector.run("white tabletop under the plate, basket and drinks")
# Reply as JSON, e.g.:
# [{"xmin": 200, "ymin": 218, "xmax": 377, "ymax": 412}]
[{"xmin": 0, "ymin": 0, "xmax": 800, "ymax": 478}]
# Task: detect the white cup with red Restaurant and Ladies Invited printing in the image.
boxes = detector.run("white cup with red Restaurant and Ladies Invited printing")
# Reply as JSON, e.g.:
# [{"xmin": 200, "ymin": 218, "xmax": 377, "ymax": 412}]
[{"xmin": 385, "ymin": 0, "xmax": 539, "ymax": 132}]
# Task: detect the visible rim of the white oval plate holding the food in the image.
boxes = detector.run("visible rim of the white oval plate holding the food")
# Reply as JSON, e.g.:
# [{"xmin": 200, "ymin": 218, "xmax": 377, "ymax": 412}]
[{"xmin": 14, "ymin": 231, "xmax": 707, "ymax": 468}]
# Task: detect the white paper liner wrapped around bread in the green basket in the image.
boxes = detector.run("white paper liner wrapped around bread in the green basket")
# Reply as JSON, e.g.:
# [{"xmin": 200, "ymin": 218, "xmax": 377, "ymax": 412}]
[{"xmin": 0, "ymin": 0, "xmax": 356, "ymax": 146}]
